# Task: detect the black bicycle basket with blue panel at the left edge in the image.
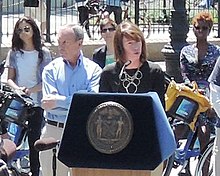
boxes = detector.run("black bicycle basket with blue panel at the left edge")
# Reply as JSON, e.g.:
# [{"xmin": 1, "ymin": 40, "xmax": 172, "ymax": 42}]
[{"xmin": 0, "ymin": 96, "xmax": 29, "ymax": 125}]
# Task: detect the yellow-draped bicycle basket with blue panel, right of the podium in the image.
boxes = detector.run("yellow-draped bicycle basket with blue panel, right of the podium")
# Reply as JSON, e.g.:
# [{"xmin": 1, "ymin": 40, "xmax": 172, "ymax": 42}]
[{"xmin": 165, "ymin": 81, "xmax": 211, "ymax": 125}]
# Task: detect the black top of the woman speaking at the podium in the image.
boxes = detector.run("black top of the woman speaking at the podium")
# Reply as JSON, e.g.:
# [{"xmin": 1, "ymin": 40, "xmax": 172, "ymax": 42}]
[{"xmin": 99, "ymin": 61, "xmax": 165, "ymax": 106}]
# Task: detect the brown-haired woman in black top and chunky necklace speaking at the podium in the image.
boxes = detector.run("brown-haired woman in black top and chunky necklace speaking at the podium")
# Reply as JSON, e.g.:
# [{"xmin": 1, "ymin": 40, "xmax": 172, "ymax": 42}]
[{"xmin": 99, "ymin": 22, "xmax": 165, "ymax": 105}]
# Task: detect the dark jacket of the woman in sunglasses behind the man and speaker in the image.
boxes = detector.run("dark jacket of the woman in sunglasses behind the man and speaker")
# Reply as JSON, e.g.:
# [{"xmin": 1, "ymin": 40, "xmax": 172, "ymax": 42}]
[{"xmin": 92, "ymin": 45, "xmax": 107, "ymax": 68}]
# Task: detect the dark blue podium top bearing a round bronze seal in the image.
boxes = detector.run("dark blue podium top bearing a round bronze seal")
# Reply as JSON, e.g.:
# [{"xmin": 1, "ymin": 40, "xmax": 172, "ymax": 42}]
[{"xmin": 58, "ymin": 92, "xmax": 176, "ymax": 170}]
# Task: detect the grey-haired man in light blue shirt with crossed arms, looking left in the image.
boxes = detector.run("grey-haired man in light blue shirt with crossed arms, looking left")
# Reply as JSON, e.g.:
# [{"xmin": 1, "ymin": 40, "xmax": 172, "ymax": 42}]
[{"xmin": 40, "ymin": 25, "xmax": 102, "ymax": 176}]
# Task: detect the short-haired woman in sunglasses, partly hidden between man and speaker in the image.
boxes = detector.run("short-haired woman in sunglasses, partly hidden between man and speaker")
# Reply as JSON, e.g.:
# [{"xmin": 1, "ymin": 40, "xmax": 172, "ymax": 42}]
[{"xmin": 92, "ymin": 18, "xmax": 117, "ymax": 68}]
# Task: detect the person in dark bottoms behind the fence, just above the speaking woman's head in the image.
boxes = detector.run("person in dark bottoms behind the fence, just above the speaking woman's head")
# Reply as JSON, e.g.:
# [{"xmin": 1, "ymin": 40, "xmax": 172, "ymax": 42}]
[{"xmin": 105, "ymin": 0, "xmax": 122, "ymax": 24}]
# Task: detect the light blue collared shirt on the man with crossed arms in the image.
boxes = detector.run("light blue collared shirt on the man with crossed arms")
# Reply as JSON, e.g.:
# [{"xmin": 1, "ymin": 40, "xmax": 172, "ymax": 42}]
[{"xmin": 42, "ymin": 52, "xmax": 102, "ymax": 123}]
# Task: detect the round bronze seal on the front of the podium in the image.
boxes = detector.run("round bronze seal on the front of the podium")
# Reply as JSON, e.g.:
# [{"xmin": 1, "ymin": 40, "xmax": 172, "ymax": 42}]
[{"xmin": 87, "ymin": 101, "xmax": 133, "ymax": 154}]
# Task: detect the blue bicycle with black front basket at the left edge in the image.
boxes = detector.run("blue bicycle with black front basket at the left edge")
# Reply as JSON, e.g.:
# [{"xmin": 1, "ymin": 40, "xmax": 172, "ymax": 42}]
[{"xmin": 0, "ymin": 87, "xmax": 34, "ymax": 176}]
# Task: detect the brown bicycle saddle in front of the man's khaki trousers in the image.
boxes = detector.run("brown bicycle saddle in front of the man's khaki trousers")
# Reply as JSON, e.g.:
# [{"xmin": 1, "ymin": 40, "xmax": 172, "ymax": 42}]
[{"xmin": 34, "ymin": 137, "xmax": 60, "ymax": 151}]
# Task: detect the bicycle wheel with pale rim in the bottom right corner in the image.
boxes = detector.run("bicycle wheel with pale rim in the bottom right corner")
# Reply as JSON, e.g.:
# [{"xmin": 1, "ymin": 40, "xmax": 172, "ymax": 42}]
[{"xmin": 195, "ymin": 140, "xmax": 214, "ymax": 176}]
